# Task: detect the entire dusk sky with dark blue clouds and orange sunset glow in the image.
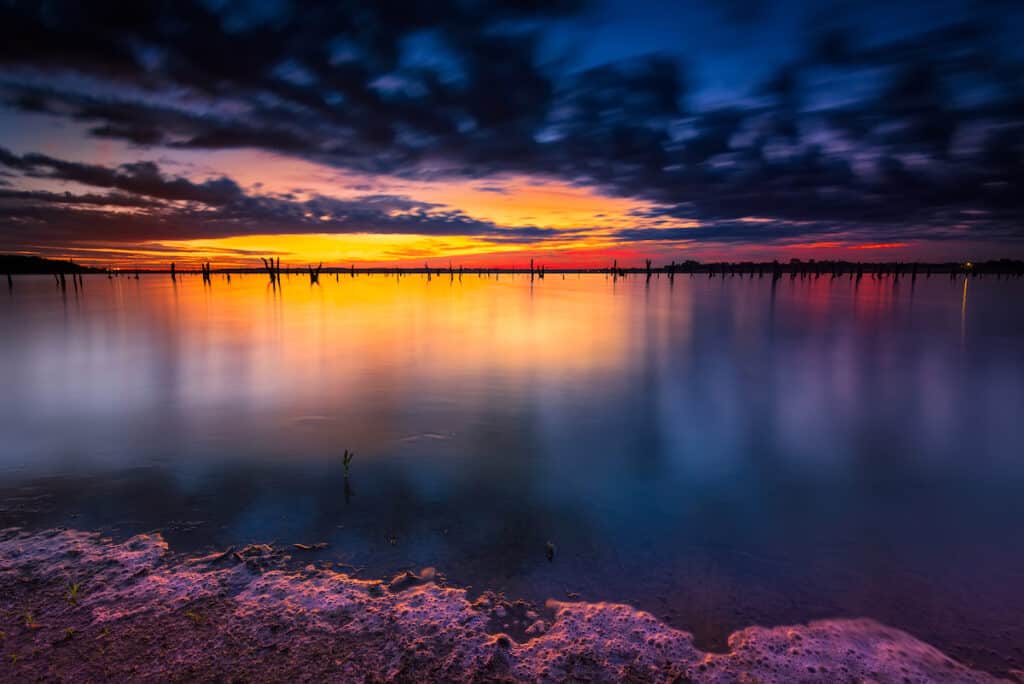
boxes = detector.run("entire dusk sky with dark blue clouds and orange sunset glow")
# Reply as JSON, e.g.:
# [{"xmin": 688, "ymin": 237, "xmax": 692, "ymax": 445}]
[{"xmin": 0, "ymin": 0, "xmax": 1024, "ymax": 267}]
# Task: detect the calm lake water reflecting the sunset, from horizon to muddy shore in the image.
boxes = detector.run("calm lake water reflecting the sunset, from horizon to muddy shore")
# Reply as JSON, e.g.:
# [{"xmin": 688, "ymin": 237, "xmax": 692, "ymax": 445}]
[{"xmin": 0, "ymin": 274, "xmax": 1024, "ymax": 671}]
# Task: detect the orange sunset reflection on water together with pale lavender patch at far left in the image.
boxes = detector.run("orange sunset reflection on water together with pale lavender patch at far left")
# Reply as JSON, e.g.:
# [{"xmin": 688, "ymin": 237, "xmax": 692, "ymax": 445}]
[{"xmin": 6, "ymin": 273, "xmax": 668, "ymax": 452}]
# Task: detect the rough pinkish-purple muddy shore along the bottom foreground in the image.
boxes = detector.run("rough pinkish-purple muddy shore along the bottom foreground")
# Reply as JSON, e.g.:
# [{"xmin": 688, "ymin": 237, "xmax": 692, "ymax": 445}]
[{"xmin": 0, "ymin": 529, "xmax": 1024, "ymax": 682}]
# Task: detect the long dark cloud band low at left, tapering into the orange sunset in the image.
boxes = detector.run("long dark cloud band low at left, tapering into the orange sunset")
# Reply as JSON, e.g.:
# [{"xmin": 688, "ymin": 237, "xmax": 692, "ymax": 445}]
[{"xmin": 0, "ymin": 147, "xmax": 567, "ymax": 245}]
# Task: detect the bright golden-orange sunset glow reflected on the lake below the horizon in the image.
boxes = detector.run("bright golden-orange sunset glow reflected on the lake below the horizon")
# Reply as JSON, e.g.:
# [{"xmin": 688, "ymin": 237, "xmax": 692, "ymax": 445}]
[{"xmin": 68, "ymin": 273, "xmax": 647, "ymax": 413}]
